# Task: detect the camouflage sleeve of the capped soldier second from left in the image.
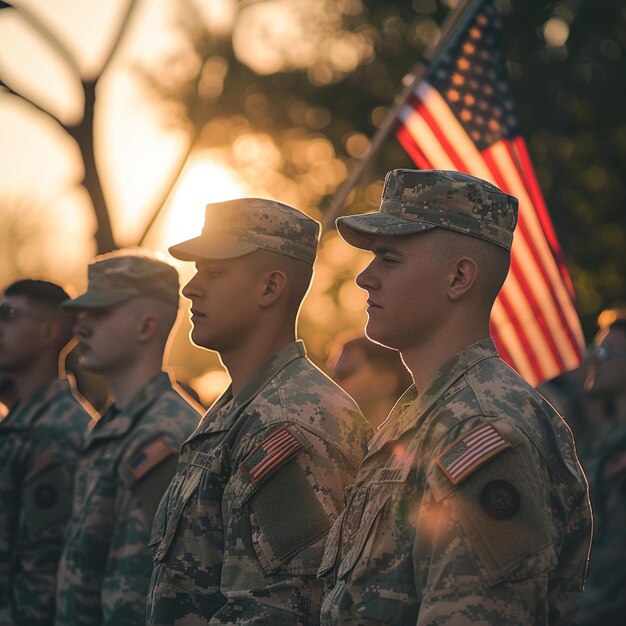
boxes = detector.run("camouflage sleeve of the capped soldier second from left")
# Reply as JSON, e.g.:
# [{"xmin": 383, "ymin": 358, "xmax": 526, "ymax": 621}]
[{"xmin": 101, "ymin": 437, "xmax": 178, "ymax": 626}]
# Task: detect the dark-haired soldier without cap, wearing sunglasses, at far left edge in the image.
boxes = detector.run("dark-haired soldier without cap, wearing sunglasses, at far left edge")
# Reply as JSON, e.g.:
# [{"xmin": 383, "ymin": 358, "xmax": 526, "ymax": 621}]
[{"xmin": 0, "ymin": 280, "xmax": 90, "ymax": 626}]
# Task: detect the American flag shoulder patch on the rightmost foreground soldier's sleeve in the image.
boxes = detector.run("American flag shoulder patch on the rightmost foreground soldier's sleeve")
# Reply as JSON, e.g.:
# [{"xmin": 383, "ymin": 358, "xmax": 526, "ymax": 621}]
[{"xmin": 436, "ymin": 424, "xmax": 511, "ymax": 485}]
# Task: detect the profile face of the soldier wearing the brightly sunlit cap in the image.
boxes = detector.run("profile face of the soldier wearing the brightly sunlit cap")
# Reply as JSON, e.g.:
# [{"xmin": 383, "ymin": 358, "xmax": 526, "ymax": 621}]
[{"xmin": 183, "ymin": 252, "xmax": 262, "ymax": 351}]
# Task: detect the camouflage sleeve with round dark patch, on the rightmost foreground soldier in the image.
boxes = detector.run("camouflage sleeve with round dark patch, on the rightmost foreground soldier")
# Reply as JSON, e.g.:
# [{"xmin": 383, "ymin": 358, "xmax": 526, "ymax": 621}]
[{"xmin": 413, "ymin": 426, "xmax": 564, "ymax": 626}]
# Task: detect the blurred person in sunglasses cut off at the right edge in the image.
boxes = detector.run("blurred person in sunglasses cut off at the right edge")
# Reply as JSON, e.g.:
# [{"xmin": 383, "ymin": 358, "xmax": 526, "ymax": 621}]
[{"xmin": 583, "ymin": 318, "xmax": 626, "ymax": 626}]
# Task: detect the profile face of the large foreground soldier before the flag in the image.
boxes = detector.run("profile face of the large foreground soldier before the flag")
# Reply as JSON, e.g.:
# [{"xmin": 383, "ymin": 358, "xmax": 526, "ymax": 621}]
[{"xmin": 356, "ymin": 231, "xmax": 448, "ymax": 351}]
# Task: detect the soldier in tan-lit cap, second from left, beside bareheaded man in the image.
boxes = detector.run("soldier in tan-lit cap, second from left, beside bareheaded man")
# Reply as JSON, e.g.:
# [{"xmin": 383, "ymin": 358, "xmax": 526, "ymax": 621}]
[{"xmin": 56, "ymin": 252, "xmax": 200, "ymax": 626}]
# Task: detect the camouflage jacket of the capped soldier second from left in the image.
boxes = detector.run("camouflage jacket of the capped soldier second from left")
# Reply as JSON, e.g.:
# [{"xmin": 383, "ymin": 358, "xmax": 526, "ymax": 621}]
[{"xmin": 55, "ymin": 373, "xmax": 200, "ymax": 626}]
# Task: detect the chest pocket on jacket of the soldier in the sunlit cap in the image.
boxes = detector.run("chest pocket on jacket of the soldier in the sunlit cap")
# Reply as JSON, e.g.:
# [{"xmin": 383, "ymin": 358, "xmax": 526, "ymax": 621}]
[{"xmin": 148, "ymin": 447, "xmax": 225, "ymax": 561}]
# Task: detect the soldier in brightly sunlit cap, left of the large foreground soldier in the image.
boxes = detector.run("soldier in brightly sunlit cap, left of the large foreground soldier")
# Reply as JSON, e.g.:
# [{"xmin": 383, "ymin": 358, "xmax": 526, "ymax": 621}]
[{"xmin": 148, "ymin": 198, "xmax": 371, "ymax": 626}]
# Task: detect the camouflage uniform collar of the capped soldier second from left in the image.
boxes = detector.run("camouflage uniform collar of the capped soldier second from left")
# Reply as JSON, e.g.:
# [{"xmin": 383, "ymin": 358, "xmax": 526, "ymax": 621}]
[{"xmin": 85, "ymin": 372, "xmax": 172, "ymax": 448}]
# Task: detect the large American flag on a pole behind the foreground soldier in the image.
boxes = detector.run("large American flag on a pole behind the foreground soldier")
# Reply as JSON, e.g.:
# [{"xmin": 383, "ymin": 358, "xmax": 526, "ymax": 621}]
[{"xmin": 396, "ymin": 0, "xmax": 584, "ymax": 385}]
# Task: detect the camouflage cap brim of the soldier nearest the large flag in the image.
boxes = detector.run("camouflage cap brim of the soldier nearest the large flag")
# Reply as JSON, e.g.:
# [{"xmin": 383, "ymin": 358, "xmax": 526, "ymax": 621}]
[{"xmin": 335, "ymin": 212, "xmax": 437, "ymax": 250}]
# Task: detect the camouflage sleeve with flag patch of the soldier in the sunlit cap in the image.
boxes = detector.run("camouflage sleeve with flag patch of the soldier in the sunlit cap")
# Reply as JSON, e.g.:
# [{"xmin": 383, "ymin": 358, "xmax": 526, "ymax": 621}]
[{"xmin": 212, "ymin": 424, "xmax": 357, "ymax": 625}]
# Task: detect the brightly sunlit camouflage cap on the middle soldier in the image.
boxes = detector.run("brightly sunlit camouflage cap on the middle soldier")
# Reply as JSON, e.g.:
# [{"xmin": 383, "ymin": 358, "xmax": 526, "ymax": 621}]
[{"xmin": 169, "ymin": 198, "xmax": 320, "ymax": 265}]
